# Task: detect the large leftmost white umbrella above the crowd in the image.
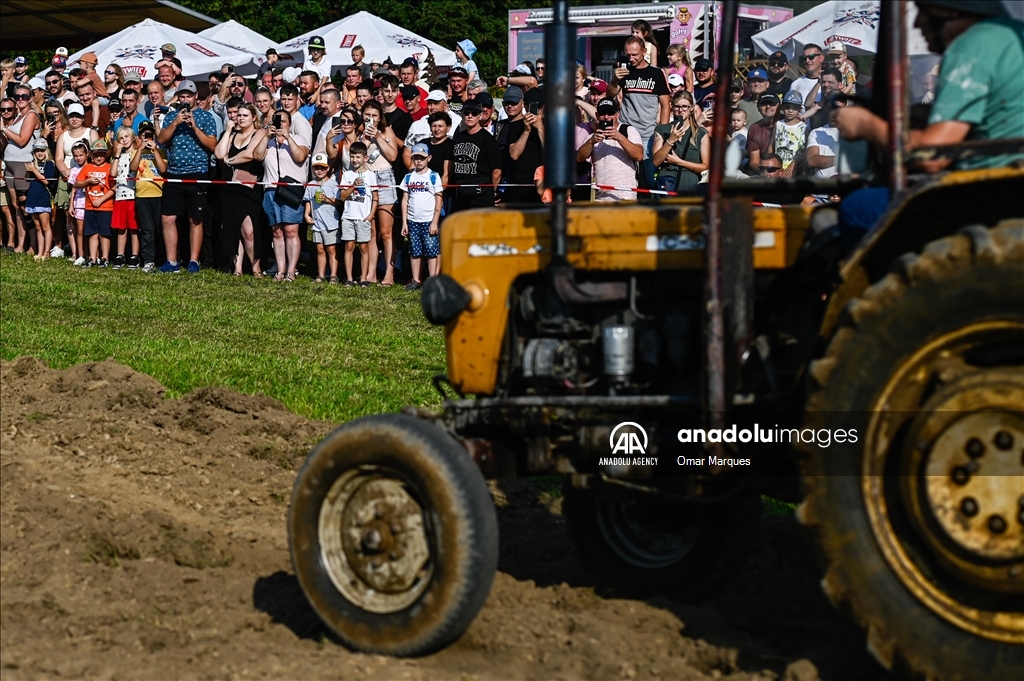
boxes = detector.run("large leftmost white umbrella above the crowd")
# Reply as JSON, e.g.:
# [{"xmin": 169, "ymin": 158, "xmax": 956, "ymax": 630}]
[{"xmin": 39, "ymin": 18, "xmax": 253, "ymax": 80}]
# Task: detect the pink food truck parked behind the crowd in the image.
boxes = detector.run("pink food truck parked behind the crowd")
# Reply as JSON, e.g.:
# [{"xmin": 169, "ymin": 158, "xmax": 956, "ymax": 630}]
[{"xmin": 509, "ymin": 0, "xmax": 793, "ymax": 80}]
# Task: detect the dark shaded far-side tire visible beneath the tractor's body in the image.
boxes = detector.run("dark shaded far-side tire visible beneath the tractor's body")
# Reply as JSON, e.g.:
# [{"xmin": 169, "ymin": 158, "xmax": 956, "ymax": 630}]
[{"xmin": 562, "ymin": 484, "xmax": 761, "ymax": 600}]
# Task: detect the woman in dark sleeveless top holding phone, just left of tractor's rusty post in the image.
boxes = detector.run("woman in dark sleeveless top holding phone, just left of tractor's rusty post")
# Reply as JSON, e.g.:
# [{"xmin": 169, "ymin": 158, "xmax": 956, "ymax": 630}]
[{"xmin": 651, "ymin": 90, "xmax": 711, "ymax": 191}]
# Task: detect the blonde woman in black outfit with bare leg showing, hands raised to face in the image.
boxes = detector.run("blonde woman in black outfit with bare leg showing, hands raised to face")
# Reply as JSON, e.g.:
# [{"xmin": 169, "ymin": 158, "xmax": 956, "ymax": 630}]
[{"xmin": 214, "ymin": 102, "xmax": 267, "ymax": 279}]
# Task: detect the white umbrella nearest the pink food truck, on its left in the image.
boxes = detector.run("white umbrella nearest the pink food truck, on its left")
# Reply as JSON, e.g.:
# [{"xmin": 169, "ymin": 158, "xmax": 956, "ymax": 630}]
[{"xmin": 278, "ymin": 11, "xmax": 455, "ymax": 73}]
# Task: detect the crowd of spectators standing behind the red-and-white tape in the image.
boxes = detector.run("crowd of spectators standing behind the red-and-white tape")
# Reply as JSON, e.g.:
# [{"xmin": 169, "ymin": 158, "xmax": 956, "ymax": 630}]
[{"xmin": 0, "ymin": 0, "xmax": 1015, "ymax": 280}]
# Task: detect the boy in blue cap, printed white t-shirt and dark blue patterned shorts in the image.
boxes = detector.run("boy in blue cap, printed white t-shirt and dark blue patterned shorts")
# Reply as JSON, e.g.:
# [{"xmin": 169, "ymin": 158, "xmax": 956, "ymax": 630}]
[{"xmin": 398, "ymin": 144, "xmax": 444, "ymax": 291}]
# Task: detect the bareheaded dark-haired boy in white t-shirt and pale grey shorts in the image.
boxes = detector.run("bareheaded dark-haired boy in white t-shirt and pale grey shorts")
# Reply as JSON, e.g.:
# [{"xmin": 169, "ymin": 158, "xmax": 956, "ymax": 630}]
[{"xmin": 338, "ymin": 142, "xmax": 377, "ymax": 286}]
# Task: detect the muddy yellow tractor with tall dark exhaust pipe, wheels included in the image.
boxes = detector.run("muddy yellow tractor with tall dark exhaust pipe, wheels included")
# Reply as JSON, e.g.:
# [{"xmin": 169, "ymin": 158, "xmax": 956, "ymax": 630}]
[{"xmin": 289, "ymin": 2, "xmax": 1024, "ymax": 680}]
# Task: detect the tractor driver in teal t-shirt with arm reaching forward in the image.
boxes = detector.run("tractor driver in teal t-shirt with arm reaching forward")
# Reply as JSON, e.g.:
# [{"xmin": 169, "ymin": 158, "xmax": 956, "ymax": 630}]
[{"xmin": 836, "ymin": 0, "xmax": 1024, "ymax": 248}]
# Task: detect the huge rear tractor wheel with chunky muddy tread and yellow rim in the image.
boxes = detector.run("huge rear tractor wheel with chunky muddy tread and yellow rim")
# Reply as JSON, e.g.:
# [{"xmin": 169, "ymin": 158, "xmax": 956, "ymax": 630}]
[{"xmin": 798, "ymin": 219, "xmax": 1024, "ymax": 681}]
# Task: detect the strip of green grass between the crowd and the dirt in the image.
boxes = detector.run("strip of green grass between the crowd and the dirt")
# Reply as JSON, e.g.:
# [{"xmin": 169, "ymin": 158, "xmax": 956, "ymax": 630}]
[{"xmin": 0, "ymin": 254, "xmax": 444, "ymax": 421}]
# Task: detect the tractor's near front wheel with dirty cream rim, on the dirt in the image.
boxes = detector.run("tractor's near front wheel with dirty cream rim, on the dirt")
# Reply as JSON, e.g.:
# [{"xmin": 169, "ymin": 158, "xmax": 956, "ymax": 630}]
[{"xmin": 288, "ymin": 415, "xmax": 498, "ymax": 656}]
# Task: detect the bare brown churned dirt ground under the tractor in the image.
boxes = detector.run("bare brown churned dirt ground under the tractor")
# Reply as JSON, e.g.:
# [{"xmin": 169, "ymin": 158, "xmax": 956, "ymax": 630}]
[{"xmin": 0, "ymin": 357, "xmax": 886, "ymax": 681}]
